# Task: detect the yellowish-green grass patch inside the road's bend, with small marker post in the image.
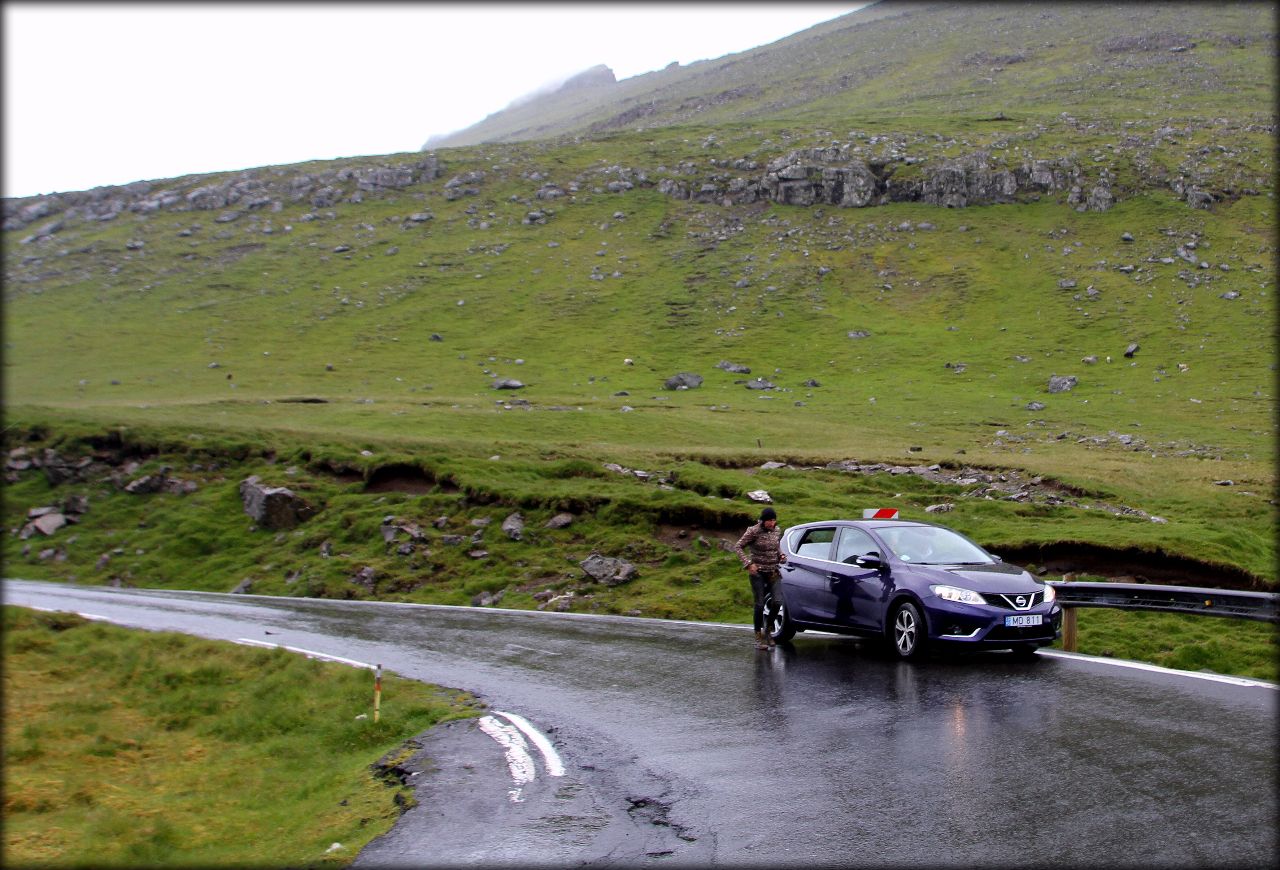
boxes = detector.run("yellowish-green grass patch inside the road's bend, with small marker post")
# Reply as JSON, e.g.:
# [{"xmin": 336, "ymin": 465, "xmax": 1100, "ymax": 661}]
[{"xmin": 4, "ymin": 606, "xmax": 477, "ymax": 867}]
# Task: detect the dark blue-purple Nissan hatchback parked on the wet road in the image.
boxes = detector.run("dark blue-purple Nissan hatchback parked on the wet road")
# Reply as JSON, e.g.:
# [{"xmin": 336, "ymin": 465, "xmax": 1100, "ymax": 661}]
[{"xmin": 765, "ymin": 510, "xmax": 1062, "ymax": 659}]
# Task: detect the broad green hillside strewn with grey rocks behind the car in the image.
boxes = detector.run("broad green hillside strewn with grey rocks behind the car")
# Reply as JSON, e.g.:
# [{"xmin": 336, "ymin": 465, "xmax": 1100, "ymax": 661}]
[{"xmin": 3, "ymin": 4, "xmax": 1277, "ymax": 642}]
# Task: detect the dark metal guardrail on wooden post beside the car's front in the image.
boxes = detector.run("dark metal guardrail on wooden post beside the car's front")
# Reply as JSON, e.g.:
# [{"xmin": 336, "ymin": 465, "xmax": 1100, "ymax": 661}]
[{"xmin": 1046, "ymin": 580, "xmax": 1280, "ymax": 653}]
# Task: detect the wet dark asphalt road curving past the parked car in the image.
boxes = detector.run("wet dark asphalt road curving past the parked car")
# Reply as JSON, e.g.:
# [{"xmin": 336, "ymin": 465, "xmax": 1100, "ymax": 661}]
[{"xmin": 4, "ymin": 581, "xmax": 1280, "ymax": 867}]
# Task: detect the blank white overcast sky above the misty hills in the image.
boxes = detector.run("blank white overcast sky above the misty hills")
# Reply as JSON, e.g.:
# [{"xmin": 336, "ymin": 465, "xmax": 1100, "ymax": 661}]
[{"xmin": 4, "ymin": 1, "xmax": 865, "ymax": 196}]
